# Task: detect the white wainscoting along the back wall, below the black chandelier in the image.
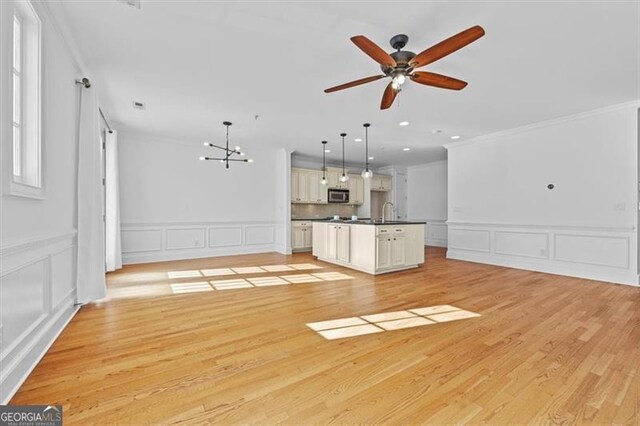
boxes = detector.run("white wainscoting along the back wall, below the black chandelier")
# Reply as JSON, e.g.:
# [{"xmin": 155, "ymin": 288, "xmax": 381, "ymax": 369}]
[{"xmin": 121, "ymin": 222, "xmax": 285, "ymax": 264}]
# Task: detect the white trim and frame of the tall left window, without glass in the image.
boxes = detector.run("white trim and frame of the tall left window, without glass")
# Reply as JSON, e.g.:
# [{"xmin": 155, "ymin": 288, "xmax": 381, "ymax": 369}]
[{"xmin": 6, "ymin": 1, "xmax": 46, "ymax": 200}]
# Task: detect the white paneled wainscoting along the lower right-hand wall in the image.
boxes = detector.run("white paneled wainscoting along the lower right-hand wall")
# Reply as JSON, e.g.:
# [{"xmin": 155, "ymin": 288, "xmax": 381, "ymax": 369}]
[{"xmin": 447, "ymin": 222, "xmax": 639, "ymax": 286}]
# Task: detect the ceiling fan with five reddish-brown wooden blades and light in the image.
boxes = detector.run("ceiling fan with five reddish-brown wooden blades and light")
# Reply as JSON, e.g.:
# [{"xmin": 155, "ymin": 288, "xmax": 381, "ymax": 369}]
[{"xmin": 325, "ymin": 25, "xmax": 484, "ymax": 109}]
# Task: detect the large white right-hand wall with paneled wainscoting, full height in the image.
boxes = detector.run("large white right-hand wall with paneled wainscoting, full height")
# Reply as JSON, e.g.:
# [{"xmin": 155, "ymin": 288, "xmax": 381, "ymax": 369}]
[{"xmin": 447, "ymin": 103, "xmax": 638, "ymax": 285}]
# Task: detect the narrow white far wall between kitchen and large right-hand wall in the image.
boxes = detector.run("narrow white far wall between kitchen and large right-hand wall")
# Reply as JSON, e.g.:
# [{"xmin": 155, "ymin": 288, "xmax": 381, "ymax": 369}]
[{"xmin": 407, "ymin": 161, "xmax": 447, "ymax": 247}]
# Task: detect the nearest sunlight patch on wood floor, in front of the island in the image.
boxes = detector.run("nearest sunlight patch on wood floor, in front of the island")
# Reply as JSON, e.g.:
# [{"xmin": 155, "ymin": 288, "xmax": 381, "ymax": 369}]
[{"xmin": 306, "ymin": 304, "xmax": 481, "ymax": 340}]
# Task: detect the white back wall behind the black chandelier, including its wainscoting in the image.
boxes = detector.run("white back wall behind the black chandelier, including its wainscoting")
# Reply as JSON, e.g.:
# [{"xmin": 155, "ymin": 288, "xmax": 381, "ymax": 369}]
[{"xmin": 118, "ymin": 131, "xmax": 288, "ymax": 263}]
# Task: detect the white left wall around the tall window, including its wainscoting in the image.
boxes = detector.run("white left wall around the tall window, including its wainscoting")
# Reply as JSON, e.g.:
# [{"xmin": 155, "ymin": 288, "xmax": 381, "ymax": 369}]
[{"xmin": 0, "ymin": 1, "xmax": 83, "ymax": 404}]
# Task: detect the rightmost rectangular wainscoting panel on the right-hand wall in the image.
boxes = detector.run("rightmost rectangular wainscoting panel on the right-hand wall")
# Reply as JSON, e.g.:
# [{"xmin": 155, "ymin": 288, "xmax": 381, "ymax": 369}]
[{"xmin": 554, "ymin": 234, "xmax": 629, "ymax": 269}]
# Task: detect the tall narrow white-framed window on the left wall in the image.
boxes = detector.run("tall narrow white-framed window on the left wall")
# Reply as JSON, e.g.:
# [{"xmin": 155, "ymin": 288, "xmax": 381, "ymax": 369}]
[{"xmin": 10, "ymin": 1, "xmax": 44, "ymax": 198}]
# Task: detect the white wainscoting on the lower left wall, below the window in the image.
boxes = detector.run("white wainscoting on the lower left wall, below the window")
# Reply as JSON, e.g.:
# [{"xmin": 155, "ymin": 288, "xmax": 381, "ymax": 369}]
[{"xmin": 0, "ymin": 231, "xmax": 77, "ymax": 404}]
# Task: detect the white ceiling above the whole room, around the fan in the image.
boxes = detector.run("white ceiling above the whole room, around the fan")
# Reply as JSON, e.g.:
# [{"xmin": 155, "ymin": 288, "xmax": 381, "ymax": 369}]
[{"xmin": 57, "ymin": 0, "xmax": 640, "ymax": 166}]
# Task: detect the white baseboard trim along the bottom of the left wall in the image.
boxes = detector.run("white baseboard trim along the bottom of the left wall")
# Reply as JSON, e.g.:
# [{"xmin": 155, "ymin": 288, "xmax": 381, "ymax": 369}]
[{"xmin": 0, "ymin": 298, "xmax": 80, "ymax": 405}]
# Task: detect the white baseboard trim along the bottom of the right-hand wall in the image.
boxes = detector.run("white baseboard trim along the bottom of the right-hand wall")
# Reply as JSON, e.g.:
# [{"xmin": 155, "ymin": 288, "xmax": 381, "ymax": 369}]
[{"xmin": 447, "ymin": 249, "xmax": 640, "ymax": 287}]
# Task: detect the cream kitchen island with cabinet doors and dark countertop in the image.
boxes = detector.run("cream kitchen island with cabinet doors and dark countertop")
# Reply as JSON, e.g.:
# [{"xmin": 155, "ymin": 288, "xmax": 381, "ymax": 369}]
[{"xmin": 313, "ymin": 220, "xmax": 425, "ymax": 275}]
